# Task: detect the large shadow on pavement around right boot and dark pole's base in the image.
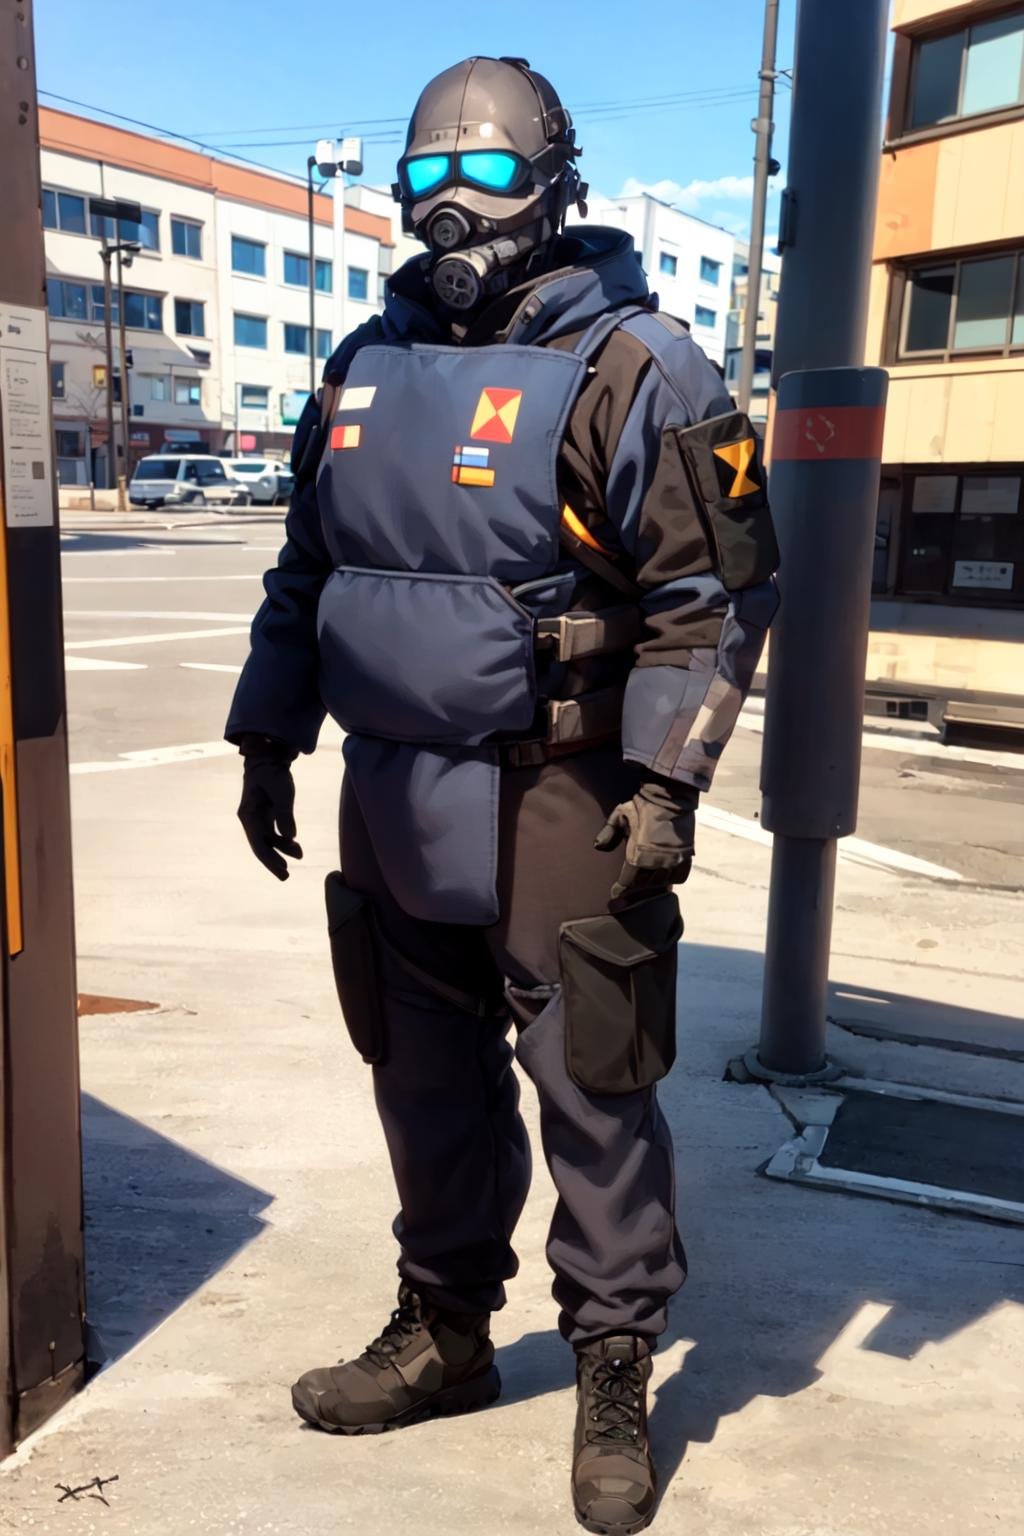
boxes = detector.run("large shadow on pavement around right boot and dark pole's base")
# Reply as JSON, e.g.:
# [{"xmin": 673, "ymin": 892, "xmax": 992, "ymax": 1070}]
[{"xmin": 497, "ymin": 945, "xmax": 1024, "ymax": 1493}]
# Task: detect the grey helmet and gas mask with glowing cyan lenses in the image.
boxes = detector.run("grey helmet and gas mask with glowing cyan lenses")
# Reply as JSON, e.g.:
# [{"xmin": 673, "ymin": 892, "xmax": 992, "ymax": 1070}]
[{"xmin": 393, "ymin": 58, "xmax": 586, "ymax": 310}]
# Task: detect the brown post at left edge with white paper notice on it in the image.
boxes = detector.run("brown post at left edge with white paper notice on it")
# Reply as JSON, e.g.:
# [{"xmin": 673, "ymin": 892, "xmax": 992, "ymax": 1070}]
[{"xmin": 0, "ymin": 0, "xmax": 84, "ymax": 1455}]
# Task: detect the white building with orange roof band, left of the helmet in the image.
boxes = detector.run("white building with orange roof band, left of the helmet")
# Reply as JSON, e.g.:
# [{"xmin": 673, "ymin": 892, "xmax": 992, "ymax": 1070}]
[{"xmin": 40, "ymin": 108, "xmax": 393, "ymax": 485}]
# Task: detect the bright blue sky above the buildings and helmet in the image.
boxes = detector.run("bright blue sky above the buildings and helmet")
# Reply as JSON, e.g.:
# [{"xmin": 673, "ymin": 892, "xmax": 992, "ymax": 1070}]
[{"xmin": 35, "ymin": 0, "xmax": 795, "ymax": 237}]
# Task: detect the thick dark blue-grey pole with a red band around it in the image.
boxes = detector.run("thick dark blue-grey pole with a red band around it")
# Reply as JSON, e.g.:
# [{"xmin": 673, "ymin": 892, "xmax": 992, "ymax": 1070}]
[{"xmin": 743, "ymin": 0, "xmax": 889, "ymax": 1083}]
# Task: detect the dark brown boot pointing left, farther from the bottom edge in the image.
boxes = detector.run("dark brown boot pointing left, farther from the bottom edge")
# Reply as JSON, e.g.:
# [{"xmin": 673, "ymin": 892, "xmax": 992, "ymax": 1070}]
[{"xmin": 292, "ymin": 1286, "xmax": 502, "ymax": 1435}]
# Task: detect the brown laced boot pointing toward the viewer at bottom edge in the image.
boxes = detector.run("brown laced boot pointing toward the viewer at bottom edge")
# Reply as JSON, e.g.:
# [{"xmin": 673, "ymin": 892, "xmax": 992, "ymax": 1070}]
[{"xmin": 573, "ymin": 1333, "xmax": 656, "ymax": 1536}]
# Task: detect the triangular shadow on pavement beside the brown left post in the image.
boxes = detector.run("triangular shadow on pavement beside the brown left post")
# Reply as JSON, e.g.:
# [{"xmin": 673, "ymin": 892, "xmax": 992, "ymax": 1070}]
[{"xmin": 81, "ymin": 1094, "xmax": 273, "ymax": 1364}]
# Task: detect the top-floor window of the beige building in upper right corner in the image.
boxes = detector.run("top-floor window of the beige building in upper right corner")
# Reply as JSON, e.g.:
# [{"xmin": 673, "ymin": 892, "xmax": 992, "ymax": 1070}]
[{"xmin": 907, "ymin": 11, "xmax": 1024, "ymax": 129}]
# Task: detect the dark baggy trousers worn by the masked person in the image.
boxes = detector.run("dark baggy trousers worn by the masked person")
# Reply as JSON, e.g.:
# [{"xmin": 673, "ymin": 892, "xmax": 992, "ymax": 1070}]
[{"xmin": 341, "ymin": 748, "xmax": 685, "ymax": 1344}]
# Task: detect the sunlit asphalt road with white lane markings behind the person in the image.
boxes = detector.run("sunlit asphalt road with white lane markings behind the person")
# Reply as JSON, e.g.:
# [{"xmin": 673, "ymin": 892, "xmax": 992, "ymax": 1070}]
[{"xmin": 63, "ymin": 515, "xmax": 1024, "ymax": 886}]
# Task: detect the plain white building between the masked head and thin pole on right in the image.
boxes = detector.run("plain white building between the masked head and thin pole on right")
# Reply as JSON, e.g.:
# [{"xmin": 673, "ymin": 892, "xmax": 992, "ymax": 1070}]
[{"xmin": 570, "ymin": 192, "xmax": 735, "ymax": 367}]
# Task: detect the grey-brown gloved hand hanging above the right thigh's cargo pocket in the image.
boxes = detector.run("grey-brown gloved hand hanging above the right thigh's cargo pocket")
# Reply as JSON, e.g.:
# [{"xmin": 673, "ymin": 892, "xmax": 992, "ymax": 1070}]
[{"xmin": 594, "ymin": 779, "xmax": 700, "ymax": 902}]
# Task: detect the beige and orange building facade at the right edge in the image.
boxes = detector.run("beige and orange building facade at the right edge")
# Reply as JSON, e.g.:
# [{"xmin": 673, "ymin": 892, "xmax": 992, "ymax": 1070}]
[{"xmin": 867, "ymin": 0, "xmax": 1024, "ymax": 715}]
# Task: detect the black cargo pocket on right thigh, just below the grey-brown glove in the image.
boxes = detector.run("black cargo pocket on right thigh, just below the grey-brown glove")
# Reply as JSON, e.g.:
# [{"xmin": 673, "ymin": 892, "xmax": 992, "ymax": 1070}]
[{"xmin": 559, "ymin": 891, "xmax": 683, "ymax": 1094}]
